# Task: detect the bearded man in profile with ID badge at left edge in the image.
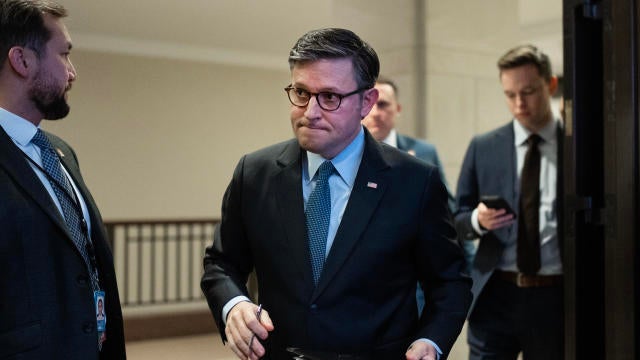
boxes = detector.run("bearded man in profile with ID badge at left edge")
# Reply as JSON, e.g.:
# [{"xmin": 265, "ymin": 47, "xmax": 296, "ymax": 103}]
[{"xmin": 0, "ymin": 0, "xmax": 126, "ymax": 360}]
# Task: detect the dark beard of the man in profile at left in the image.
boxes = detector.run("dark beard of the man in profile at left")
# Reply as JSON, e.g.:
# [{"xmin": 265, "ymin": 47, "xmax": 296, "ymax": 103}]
[{"xmin": 29, "ymin": 71, "xmax": 71, "ymax": 120}]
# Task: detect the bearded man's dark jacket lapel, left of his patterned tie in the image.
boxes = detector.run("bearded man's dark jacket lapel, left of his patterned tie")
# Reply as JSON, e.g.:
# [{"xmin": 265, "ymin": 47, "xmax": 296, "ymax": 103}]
[{"xmin": 0, "ymin": 127, "xmax": 71, "ymax": 236}]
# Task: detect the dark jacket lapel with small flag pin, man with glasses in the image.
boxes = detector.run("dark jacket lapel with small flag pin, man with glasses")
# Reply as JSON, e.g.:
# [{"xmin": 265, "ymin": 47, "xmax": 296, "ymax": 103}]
[{"xmin": 311, "ymin": 130, "xmax": 389, "ymax": 301}]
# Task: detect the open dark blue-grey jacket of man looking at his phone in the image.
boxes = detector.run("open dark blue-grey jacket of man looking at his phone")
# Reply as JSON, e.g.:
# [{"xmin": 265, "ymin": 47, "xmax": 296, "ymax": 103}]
[{"xmin": 455, "ymin": 122, "xmax": 562, "ymax": 314}]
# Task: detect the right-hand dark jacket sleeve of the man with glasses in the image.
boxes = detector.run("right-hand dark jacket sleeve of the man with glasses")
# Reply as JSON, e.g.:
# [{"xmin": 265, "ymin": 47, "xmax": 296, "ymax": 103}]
[{"xmin": 418, "ymin": 166, "xmax": 472, "ymax": 354}]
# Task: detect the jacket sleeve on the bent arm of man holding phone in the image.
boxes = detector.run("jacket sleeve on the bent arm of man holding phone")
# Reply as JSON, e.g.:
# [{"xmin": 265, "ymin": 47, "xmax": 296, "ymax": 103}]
[{"xmin": 455, "ymin": 139, "xmax": 479, "ymax": 240}]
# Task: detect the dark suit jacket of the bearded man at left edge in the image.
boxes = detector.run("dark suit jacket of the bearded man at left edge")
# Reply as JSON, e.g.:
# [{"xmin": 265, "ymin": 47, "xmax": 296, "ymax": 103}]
[{"xmin": 0, "ymin": 127, "xmax": 126, "ymax": 360}]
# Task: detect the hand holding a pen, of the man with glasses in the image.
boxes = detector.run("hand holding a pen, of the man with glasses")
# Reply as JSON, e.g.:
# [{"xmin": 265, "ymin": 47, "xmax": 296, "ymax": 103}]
[{"xmin": 224, "ymin": 301, "xmax": 273, "ymax": 360}]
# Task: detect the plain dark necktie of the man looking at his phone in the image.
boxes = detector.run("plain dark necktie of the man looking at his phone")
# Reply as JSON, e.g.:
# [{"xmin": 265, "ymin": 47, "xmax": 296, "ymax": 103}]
[{"xmin": 517, "ymin": 134, "xmax": 542, "ymax": 274}]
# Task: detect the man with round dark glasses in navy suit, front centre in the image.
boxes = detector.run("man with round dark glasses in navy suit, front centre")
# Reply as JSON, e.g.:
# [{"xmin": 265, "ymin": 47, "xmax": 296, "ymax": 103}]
[{"xmin": 202, "ymin": 29, "xmax": 470, "ymax": 360}]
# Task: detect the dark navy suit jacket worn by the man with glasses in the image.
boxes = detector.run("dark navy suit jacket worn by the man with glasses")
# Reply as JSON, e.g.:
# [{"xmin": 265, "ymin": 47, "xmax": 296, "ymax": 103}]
[{"xmin": 202, "ymin": 130, "xmax": 470, "ymax": 359}]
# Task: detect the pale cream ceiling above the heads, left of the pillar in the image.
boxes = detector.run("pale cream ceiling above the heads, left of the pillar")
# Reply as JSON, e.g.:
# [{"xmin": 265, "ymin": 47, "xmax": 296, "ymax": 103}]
[{"xmin": 59, "ymin": 0, "xmax": 413, "ymax": 66}]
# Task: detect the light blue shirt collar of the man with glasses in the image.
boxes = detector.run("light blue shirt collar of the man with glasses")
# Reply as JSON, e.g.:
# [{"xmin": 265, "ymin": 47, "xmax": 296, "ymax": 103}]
[{"xmin": 307, "ymin": 127, "xmax": 364, "ymax": 187}]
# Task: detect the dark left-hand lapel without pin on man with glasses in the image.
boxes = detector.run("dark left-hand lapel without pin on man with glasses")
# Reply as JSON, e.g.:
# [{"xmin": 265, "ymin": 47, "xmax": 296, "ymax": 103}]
[{"xmin": 275, "ymin": 140, "xmax": 313, "ymax": 284}]
